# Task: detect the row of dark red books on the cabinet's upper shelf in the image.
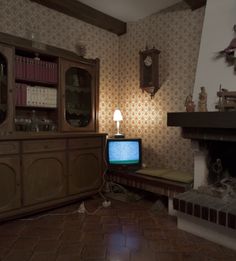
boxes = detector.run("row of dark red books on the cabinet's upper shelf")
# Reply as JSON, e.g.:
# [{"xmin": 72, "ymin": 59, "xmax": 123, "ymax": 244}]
[{"xmin": 15, "ymin": 55, "xmax": 58, "ymax": 84}]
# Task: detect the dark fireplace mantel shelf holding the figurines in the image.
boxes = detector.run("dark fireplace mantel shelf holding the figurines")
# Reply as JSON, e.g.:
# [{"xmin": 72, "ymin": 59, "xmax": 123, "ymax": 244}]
[{"xmin": 167, "ymin": 111, "xmax": 236, "ymax": 141}]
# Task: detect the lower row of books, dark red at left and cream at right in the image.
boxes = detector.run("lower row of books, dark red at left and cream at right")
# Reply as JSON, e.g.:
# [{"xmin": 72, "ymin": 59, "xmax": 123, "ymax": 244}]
[{"xmin": 16, "ymin": 83, "xmax": 57, "ymax": 108}]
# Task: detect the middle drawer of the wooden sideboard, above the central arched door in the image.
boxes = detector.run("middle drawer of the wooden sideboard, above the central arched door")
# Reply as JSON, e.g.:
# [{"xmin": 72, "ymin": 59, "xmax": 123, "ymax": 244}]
[{"xmin": 22, "ymin": 140, "xmax": 66, "ymax": 153}]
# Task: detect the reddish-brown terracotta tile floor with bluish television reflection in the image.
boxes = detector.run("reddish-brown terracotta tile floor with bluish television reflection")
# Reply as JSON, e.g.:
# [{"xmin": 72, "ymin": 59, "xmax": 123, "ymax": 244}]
[{"xmin": 0, "ymin": 195, "xmax": 236, "ymax": 261}]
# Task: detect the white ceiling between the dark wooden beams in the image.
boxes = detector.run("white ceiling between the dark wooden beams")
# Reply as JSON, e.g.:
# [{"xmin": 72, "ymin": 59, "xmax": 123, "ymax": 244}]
[{"xmin": 79, "ymin": 0, "xmax": 181, "ymax": 22}]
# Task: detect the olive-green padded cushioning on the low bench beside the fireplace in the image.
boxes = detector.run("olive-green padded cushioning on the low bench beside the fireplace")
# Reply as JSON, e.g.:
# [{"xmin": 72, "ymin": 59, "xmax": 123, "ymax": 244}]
[{"xmin": 136, "ymin": 169, "xmax": 193, "ymax": 184}]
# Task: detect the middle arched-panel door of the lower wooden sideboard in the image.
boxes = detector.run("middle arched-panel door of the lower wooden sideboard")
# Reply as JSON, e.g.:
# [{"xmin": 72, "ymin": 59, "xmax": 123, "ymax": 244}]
[{"xmin": 23, "ymin": 152, "xmax": 67, "ymax": 206}]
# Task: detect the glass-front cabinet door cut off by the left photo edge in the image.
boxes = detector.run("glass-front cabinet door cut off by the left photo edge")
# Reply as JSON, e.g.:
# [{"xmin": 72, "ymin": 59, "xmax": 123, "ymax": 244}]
[{"xmin": 0, "ymin": 45, "xmax": 13, "ymax": 133}]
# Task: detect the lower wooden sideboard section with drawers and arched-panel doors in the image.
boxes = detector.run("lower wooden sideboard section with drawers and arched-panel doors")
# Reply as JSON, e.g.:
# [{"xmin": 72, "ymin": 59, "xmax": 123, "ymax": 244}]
[{"xmin": 0, "ymin": 133, "xmax": 106, "ymax": 220}]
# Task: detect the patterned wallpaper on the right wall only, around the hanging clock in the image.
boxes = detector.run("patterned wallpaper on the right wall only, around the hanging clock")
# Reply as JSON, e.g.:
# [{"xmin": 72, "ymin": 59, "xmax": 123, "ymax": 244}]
[{"xmin": 119, "ymin": 3, "xmax": 204, "ymax": 171}]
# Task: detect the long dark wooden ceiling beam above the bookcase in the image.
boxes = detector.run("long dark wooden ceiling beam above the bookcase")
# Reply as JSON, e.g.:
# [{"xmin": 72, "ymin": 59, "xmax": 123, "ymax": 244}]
[{"xmin": 31, "ymin": 0, "xmax": 126, "ymax": 35}]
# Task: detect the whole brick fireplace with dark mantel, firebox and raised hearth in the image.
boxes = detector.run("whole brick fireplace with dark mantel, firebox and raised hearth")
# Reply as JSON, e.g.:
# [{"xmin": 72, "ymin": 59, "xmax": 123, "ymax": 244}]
[{"xmin": 167, "ymin": 112, "xmax": 236, "ymax": 250}]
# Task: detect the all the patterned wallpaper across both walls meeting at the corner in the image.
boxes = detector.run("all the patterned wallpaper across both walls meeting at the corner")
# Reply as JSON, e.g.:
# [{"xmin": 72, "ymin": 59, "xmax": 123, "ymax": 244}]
[{"xmin": 0, "ymin": 0, "xmax": 204, "ymax": 171}]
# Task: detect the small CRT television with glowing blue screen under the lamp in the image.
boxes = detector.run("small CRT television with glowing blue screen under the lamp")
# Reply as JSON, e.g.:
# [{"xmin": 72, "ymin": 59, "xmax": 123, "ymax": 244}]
[{"xmin": 106, "ymin": 138, "xmax": 142, "ymax": 170}]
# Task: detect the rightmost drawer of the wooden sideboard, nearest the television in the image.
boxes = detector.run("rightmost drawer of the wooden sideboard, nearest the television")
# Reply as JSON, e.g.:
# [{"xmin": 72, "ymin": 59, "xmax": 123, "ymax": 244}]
[{"xmin": 69, "ymin": 138, "xmax": 102, "ymax": 149}]
